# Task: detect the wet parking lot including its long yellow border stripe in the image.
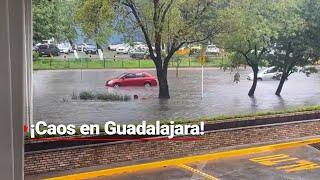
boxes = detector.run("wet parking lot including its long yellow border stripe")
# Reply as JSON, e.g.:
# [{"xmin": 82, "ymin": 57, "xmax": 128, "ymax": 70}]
[{"xmin": 45, "ymin": 138, "xmax": 320, "ymax": 180}]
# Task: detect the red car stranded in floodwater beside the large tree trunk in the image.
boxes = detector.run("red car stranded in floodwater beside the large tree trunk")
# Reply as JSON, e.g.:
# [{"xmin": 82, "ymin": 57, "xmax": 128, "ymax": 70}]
[{"xmin": 106, "ymin": 72, "xmax": 158, "ymax": 87}]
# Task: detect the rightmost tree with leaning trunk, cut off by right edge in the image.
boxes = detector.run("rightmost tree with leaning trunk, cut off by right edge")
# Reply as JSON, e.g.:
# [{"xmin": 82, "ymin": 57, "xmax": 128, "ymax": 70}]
[{"xmin": 268, "ymin": 0, "xmax": 320, "ymax": 96}]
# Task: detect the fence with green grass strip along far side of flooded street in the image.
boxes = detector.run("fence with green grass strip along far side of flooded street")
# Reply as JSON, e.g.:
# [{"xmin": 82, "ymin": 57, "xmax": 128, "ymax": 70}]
[{"xmin": 33, "ymin": 56, "xmax": 228, "ymax": 70}]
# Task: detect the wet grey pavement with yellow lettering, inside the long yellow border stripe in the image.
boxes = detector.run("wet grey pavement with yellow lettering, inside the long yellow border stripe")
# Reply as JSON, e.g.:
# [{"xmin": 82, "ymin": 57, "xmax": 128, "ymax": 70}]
[{"xmin": 94, "ymin": 145, "xmax": 320, "ymax": 180}]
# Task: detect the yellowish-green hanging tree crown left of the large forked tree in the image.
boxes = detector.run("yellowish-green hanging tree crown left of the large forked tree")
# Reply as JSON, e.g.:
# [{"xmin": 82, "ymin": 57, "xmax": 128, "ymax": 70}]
[{"xmin": 75, "ymin": 0, "xmax": 114, "ymax": 49}]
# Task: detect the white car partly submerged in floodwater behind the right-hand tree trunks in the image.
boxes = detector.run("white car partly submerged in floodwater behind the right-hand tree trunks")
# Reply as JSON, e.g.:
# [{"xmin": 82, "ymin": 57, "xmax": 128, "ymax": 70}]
[{"xmin": 247, "ymin": 67, "xmax": 282, "ymax": 81}]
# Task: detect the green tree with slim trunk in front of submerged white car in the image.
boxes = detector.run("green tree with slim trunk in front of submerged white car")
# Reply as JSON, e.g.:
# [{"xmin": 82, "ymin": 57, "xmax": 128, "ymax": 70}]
[{"xmin": 219, "ymin": 0, "xmax": 276, "ymax": 97}]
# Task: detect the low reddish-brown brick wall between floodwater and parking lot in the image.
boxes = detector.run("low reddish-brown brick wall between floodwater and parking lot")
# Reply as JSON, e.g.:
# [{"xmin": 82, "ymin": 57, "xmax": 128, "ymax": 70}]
[{"xmin": 25, "ymin": 120, "xmax": 320, "ymax": 174}]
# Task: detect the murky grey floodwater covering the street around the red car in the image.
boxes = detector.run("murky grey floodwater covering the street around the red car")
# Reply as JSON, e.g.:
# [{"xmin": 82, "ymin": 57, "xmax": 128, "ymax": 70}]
[{"xmin": 34, "ymin": 68, "xmax": 320, "ymax": 124}]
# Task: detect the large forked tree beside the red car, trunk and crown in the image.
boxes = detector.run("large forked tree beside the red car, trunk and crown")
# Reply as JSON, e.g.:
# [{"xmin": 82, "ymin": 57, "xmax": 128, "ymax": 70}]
[{"xmin": 116, "ymin": 0, "xmax": 225, "ymax": 99}]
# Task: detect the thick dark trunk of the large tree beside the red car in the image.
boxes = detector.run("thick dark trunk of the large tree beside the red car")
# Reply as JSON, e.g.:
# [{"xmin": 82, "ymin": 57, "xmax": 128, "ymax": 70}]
[{"xmin": 156, "ymin": 63, "xmax": 170, "ymax": 99}]
